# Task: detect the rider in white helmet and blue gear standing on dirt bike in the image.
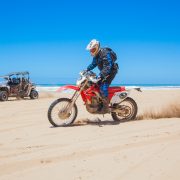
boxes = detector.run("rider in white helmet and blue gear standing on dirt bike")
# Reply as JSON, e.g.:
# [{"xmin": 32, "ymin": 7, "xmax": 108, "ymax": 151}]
[{"xmin": 86, "ymin": 39, "xmax": 118, "ymax": 112}]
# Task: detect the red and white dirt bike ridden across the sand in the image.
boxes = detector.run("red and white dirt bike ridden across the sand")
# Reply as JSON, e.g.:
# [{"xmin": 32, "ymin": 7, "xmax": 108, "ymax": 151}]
[{"xmin": 48, "ymin": 71, "xmax": 140, "ymax": 127}]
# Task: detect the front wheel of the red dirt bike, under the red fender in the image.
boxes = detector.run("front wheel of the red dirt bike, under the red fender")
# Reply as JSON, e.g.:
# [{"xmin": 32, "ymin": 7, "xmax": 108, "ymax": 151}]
[{"xmin": 48, "ymin": 98, "xmax": 78, "ymax": 127}]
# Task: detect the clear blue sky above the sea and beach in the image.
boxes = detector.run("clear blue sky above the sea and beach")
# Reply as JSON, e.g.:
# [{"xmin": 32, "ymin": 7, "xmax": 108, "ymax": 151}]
[{"xmin": 0, "ymin": 0, "xmax": 180, "ymax": 84}]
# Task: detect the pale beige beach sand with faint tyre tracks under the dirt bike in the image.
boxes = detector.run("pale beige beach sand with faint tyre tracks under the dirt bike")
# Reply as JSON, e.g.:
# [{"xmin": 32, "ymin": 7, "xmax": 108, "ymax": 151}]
[{"xmin": 0, "ymin": 90, "xmax": 180, "ymax": 180}]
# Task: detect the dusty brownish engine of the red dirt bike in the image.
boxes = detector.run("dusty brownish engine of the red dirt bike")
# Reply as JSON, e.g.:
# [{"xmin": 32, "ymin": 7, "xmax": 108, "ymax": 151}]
[{"xmin": 86, "ymin": 97, "xmax": 101, "ymax": 114}]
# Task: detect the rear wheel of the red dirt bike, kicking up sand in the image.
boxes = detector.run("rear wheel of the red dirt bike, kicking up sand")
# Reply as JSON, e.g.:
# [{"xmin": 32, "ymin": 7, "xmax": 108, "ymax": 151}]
[{"xmin": 111, "ymin": 97, "xmax": 138, "ymax": 121}]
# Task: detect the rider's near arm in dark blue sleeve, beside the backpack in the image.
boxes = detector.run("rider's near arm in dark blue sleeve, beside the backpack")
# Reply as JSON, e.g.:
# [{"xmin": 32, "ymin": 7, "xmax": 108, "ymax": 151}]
[{"xmin": 100, "ymin": 52, "xmax": 113, "ymax": 78}]
